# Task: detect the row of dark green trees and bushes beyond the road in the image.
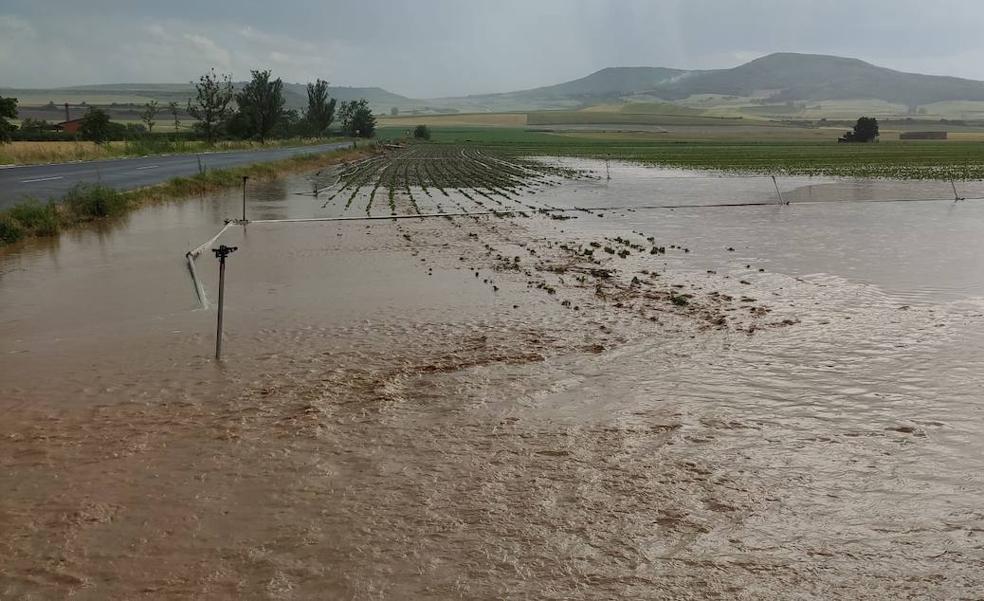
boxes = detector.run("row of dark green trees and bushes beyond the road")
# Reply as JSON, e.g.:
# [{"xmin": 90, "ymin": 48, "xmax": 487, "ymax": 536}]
[{"xmin": 0, "ymin": 69, "xmax": 376, "ymax": 144}]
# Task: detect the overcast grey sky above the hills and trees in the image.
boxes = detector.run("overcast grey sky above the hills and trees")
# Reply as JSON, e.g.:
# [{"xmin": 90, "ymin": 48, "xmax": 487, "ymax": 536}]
[{"xmin": 0, "ymin": 0, "xmax": 984, "ymax": 97}]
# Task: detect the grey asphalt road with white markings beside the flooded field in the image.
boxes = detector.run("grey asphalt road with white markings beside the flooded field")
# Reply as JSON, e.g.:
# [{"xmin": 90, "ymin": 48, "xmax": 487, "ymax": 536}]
[{"xmin": 0, "ymin": 142, "xmax": 351, "ymax": 210}]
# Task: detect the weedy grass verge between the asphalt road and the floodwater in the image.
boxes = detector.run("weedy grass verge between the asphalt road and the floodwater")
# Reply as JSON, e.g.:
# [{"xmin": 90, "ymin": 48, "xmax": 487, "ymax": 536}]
[{"xmin": 0, "ymin": 148, "xmax": 375, "ymax": 246}]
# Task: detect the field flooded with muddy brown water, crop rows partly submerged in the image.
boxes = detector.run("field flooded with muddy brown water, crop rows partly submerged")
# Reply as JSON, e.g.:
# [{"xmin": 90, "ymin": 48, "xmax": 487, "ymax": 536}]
[{"xmin": 0, "ymin": 156, "xmax": 984, "ymax": 599}]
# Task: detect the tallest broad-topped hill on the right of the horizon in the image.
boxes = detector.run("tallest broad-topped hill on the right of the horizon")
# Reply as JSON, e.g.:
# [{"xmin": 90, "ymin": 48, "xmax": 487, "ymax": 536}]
[{"xmin": 649, "ymin": 53, "xmax": 984, "ymax": 106}]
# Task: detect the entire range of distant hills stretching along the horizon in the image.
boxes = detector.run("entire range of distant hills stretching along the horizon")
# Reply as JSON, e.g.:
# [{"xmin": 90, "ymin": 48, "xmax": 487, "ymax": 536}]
[{"xmin": 11, "ymin": 53, "xmax": 984, "ymax": 114}]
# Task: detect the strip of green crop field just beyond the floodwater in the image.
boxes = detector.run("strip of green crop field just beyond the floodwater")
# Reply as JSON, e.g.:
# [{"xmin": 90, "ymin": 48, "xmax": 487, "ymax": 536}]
[{"xmin": 380, "ymin": 127, "xmax": 984, "ymax": 180}]
